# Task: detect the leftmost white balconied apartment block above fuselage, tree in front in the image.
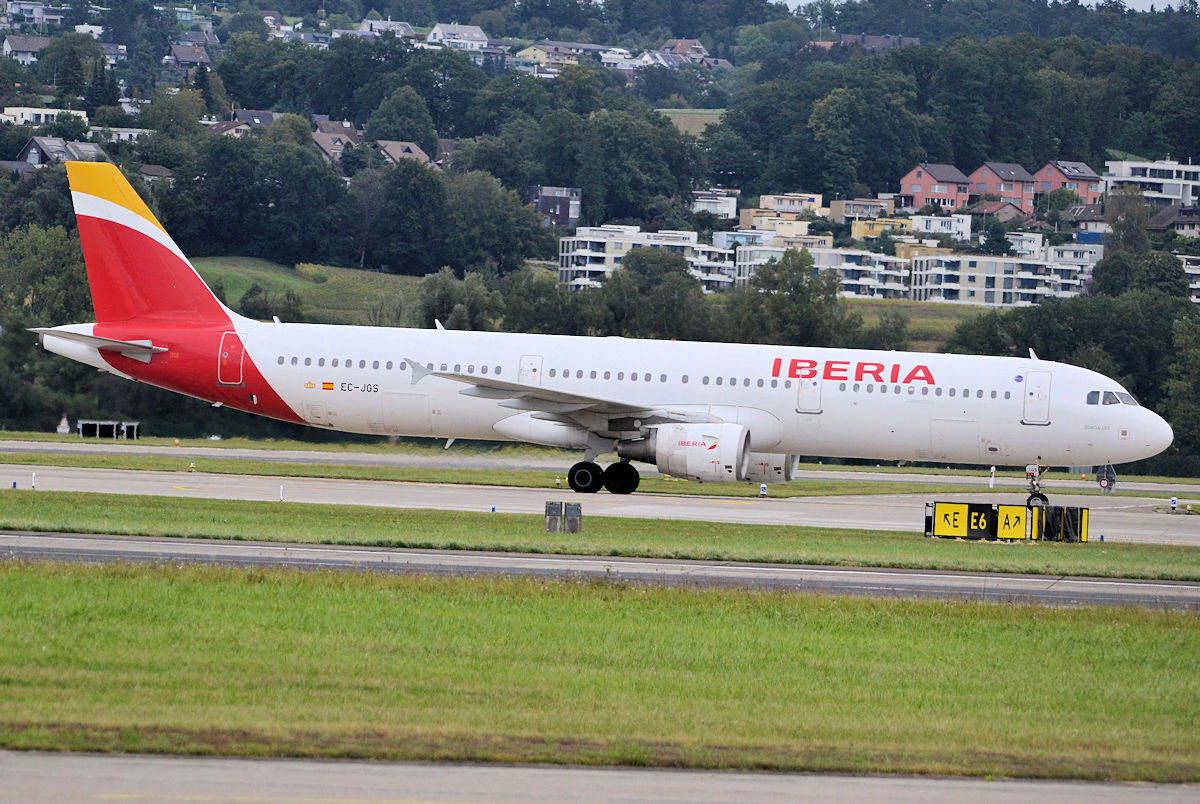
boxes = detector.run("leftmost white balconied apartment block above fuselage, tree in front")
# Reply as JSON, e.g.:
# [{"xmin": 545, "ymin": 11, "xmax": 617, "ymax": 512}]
[{"xmin": 558, "ymin": 224, "xmax": 733, "ymax": 290}]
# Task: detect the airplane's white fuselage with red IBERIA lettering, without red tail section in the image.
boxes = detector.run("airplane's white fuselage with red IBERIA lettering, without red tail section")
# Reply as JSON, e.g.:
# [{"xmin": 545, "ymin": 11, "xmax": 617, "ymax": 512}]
[{"xmin": 238, "ymin": 320, "xmax": 1171, "ymax": 466}]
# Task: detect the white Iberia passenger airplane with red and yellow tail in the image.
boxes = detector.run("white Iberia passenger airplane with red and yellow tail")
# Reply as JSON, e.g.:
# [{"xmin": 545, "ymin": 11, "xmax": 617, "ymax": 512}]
[{"xmin": 34, "ymin": 162, "xmax": 1172, "ymax": 504}]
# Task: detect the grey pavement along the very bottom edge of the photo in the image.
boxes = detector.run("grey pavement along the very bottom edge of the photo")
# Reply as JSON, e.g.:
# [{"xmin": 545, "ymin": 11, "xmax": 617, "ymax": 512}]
[{"xmin": 0, "ymin": 751, "xmax": 1200, "ymax": 804}]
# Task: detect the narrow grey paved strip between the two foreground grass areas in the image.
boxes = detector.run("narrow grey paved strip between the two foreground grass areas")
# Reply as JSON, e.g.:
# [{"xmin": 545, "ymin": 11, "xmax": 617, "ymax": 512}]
[{"xmin": 0, "ymin": 532, "xmax": 1200, "ymax": 611}]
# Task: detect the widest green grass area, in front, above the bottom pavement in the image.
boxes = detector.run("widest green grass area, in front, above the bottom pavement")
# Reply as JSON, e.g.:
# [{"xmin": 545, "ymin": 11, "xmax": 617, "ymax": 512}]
[{"xmin": 0, "ymin": 563, "xmax": 1200, "ymax": 781}]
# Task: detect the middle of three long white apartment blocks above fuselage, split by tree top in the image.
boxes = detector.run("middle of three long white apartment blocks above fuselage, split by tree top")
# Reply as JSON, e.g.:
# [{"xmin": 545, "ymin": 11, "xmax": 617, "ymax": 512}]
[{"xmin": 736, "ymin": 245, "xmax": 908, "ymax": 299}]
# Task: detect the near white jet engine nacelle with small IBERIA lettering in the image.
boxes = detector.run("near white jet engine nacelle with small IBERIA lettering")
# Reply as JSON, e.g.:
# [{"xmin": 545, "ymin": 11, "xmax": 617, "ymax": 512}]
[{"xmin": 617, "ymin": 424, "xmax": 750, "ymax": 482}]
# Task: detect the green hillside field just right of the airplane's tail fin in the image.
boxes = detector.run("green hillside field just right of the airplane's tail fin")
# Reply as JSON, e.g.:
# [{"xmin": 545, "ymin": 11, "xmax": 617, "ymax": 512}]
[{"xmin": 192, "ymin": 257, "xmax": 421, "ymax": 325}]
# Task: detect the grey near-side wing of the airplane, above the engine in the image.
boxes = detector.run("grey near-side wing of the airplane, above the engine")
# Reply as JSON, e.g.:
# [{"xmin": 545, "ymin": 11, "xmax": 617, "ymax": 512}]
[{"xmin": 408, "ymin": 359, "xmax": 716, "ymax": 426}]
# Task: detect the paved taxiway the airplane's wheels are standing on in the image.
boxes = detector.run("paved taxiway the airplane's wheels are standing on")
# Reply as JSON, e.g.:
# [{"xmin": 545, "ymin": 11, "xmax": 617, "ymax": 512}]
[{"xmin": 0, "ymin": 464, "xmax": 1200, "ymax": 545}]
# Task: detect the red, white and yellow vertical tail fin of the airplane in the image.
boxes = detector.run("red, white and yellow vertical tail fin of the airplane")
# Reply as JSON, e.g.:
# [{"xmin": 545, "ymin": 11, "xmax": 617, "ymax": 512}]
[{"xmin": 67, "ymin": 162, "xmax": 232, "ymax": 324}]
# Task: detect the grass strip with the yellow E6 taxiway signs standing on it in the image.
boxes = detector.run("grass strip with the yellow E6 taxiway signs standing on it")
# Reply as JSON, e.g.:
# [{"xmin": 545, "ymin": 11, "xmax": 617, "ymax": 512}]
[{"xmin": 7, "ymin": 490, "xmax": 1200, "ymax": 581}]
